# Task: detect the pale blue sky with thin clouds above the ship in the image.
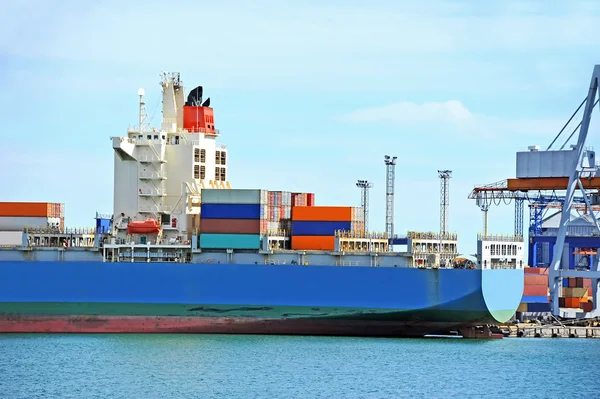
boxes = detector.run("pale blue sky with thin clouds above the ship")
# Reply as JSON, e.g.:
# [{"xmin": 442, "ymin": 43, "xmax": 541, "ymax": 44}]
[{"xmin": 0, "ymin": 0, "xmax": 600, "ymax": 254}]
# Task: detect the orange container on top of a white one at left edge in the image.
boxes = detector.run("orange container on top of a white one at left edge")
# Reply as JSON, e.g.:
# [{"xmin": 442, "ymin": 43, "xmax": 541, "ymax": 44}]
[{"xmin": 0, "ymin": 202, "xmax": 65, "ymax": 231}]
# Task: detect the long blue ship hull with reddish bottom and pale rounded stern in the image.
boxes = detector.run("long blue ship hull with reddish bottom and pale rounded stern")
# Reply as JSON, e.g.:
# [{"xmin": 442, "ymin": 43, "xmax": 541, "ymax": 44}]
[{"xmin": 0, "ymin": 261, "xmax": 523, "ymax": 336}]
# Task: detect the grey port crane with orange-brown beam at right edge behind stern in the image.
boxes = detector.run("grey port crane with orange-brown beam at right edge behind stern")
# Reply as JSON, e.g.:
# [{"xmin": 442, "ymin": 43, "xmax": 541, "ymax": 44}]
[{"xmin": 469, "ymin": 65, "xmax": 600, "ymax": 318}]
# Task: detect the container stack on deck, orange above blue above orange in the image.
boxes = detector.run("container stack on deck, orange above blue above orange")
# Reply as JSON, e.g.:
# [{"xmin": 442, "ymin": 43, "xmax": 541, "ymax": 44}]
[{"xmin": 291, "ymin": 206, "xmax": 352, "ymax": 251}]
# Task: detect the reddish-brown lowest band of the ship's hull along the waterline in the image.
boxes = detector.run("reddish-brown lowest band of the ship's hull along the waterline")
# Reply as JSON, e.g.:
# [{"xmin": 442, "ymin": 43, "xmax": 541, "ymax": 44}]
[{"xmin": 0, "ymin": 316, "xmax": 498, "ymax": 338}]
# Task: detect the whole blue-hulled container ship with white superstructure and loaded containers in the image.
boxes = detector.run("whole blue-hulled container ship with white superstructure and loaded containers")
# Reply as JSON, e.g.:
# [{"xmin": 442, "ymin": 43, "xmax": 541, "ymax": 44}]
[{"xmin": 0, "ymin": 73, "xmax": 524, "ymax": 338}]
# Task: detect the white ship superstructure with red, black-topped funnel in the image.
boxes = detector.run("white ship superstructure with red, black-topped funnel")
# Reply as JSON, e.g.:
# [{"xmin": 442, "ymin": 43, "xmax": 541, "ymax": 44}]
[{"xmin": 112, "ymin": 73, "xmax": 230, "ymax": 243}]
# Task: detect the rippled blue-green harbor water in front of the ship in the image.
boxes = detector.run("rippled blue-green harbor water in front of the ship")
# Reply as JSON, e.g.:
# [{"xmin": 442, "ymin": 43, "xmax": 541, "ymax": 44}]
[{"xmin": 0, "ymin": 334, "xmax": 600, "ymax": 399}]
